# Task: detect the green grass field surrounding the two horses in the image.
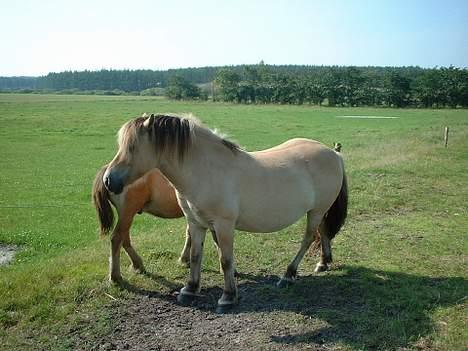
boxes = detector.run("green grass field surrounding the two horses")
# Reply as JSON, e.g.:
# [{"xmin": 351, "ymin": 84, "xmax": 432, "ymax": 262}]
[{"xmin": 0, "ymin": 95, "xmax": 468, "ymax": 350}]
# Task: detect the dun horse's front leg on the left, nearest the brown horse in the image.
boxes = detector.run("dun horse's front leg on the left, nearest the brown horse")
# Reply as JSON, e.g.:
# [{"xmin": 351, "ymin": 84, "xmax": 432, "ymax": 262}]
[{"xmin": 177, "ymin": 221, "xmax": 206, "ymax": 305}]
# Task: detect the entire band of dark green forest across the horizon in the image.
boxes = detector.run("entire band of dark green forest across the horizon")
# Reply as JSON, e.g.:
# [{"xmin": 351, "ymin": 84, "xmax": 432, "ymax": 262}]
[{"xmin": 0, "ymin": 62, "xmax": 468, "ymax": 108}]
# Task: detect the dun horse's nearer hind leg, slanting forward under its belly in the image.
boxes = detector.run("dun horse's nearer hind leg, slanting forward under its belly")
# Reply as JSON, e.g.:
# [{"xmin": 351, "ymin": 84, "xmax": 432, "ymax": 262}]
[{"xmin": 278, "ymin": 211, "xmax": 323, "ymax": 287}]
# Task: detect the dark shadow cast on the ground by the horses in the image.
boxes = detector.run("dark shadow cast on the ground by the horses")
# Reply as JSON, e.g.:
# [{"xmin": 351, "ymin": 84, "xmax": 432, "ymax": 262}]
[{"xmin": 121, "ymin": 266, "xmax": 468, "ymax": 349}]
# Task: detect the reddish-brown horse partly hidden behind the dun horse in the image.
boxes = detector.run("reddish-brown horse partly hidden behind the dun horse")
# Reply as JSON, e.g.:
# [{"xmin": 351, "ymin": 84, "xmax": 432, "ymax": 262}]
[{"xmin": 92, "ymin": 165, "xmax": 190, "ymax": 282}]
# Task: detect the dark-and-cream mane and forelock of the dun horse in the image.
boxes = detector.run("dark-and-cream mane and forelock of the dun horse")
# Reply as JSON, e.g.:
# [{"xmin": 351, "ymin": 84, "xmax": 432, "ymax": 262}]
[{"xmin": 118, "ymin": 114, "xmax": 241, "ymax": 160}]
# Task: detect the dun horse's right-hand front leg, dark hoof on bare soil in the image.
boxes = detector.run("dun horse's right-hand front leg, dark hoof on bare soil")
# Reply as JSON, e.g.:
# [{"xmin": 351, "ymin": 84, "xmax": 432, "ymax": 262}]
[{"xmin": 214, "ymin": 221, "xmax": 239, "ymax": 313}]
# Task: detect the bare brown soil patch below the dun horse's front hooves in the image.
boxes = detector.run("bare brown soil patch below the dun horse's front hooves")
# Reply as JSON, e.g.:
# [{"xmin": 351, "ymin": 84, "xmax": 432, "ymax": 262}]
[{"xmin": 73, "ymin": 276, "xmax": 346, "ymax": 351}]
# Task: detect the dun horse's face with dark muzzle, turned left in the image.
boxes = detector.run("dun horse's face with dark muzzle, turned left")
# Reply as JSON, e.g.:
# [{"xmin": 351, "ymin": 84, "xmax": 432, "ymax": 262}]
[{"xmin": 103, "ymin": 118, "xmax": 157, "ymax": 194}]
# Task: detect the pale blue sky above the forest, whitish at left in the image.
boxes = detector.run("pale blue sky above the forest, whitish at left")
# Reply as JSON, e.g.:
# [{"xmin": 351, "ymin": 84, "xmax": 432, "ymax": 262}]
[{"xmin": 0, "ymin": 0, "xmax": 468, "ymax": 76}]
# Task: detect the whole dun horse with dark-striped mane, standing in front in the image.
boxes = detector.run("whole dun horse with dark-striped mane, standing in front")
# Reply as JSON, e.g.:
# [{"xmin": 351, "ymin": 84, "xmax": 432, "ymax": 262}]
[{"xmin": 103, "ymin": 115, "xmax": 348, "ymax": 312}]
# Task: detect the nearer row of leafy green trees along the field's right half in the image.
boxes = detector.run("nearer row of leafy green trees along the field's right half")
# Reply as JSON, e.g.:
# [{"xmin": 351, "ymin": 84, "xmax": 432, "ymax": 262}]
[{"xmin": 215, "ymin": 64, "xmax": 468, "ymax": 108}]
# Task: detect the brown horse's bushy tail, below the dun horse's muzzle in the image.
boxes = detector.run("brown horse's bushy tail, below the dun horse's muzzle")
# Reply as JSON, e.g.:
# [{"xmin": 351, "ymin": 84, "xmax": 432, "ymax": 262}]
[{"xmin": 92, "ymin": 165, "xmax": 114, "ymax": 236}]
